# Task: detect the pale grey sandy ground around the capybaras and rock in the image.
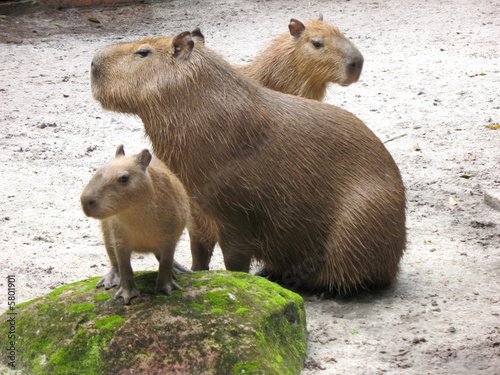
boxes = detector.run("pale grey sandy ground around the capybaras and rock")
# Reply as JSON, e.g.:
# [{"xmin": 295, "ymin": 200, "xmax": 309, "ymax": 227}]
[{"xmin": 0, "ymin": 0, "xmax": 500, "ymax": 375}]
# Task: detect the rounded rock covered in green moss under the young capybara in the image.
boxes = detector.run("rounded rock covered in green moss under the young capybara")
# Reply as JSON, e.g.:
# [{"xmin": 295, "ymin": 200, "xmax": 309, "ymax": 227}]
[{"xmin": 0, "ymin": 271, "xmax": 307, "ymax": 375}]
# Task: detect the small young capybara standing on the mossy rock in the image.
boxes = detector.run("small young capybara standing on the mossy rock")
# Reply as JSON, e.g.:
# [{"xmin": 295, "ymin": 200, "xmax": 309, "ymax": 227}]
[{"xmin": 81, "ymin": 146, "xmax": 190, "ymax": 304}]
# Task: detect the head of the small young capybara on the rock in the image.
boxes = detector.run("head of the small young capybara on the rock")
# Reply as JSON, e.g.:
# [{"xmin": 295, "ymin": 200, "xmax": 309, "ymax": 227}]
[{"xmin": 80, "ymin": 145, "xmax": 152, "ymax": 219}]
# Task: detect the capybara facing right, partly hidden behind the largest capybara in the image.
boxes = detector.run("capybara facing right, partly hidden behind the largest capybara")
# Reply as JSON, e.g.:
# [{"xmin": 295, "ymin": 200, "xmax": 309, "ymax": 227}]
[{"xmin": 236, "ymin": 17, "xmax": 364, "ymax": 100}]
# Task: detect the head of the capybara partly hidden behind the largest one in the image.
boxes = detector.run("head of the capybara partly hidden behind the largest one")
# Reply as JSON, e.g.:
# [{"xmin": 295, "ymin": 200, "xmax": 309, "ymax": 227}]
[{"xmin": 288, "ymin": 17, "xmax": 364, "ymax": 86}]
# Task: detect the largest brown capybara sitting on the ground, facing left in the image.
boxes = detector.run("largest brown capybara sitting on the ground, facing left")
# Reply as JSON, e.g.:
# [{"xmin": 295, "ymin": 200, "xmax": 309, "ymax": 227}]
[{"xmin": 91, "ymin": 32, "xmax": 406, "ymax": 294}]
